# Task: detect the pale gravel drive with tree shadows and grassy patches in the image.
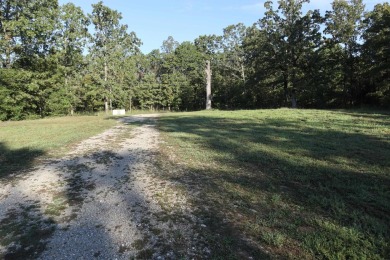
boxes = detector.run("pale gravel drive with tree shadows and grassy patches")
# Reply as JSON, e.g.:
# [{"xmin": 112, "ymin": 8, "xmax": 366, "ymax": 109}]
[{"xmin": 0, "ymin": 115, "xmax": 203, "ymax": 259}]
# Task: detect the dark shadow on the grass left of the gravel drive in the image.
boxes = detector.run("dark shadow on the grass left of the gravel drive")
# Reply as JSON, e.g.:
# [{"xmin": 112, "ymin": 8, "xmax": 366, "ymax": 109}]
[{"xmin": 0, "ymin": 142, "xmax": 45, "ymax": 181}]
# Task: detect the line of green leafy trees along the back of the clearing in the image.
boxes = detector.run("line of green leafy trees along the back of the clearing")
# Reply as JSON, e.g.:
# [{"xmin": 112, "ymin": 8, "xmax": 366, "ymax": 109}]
[{"xmin": 0, "ymin": 0, "xmax": 390, "ymax": 120}]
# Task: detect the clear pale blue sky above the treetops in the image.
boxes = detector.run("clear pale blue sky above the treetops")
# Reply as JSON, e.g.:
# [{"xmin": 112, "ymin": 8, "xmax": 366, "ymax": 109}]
[{"xmin": 59, "ymin": 0, "xmax": 385, "ymax": 53}]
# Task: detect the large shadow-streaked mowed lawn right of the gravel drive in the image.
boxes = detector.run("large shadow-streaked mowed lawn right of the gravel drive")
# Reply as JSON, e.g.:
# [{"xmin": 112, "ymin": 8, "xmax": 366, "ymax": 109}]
[{"xmin": 158, "ymin": 109, "xmax": 390, "ymax": 259}]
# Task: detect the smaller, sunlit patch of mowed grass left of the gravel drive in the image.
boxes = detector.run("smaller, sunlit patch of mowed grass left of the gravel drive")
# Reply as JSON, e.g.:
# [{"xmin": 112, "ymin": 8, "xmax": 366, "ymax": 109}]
[{"xmin": 0, "ymin": 116, "xmax": 116, "ymax": 180}]
